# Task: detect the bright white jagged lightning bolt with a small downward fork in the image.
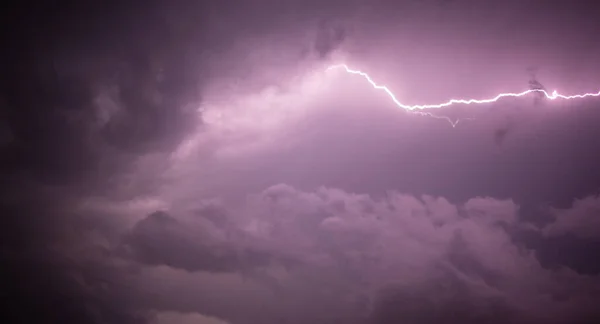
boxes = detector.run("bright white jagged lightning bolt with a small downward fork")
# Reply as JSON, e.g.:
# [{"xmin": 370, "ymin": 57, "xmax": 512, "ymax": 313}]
[{"xmin": 327, "ymin": 64, "xmax": 600, "ymax": 127}]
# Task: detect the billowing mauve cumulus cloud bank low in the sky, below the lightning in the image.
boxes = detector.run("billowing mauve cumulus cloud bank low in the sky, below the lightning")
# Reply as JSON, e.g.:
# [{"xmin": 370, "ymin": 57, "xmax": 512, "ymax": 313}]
[{"xmin": 59, "ymin": 184, "xmax": 598, "ymax": 323}]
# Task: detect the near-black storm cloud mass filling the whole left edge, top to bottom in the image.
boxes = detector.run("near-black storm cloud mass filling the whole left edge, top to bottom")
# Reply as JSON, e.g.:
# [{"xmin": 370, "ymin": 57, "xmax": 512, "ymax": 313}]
[{"xmin": 1, "ymin": 3, "xmax": 213, "ymax": 323}]
